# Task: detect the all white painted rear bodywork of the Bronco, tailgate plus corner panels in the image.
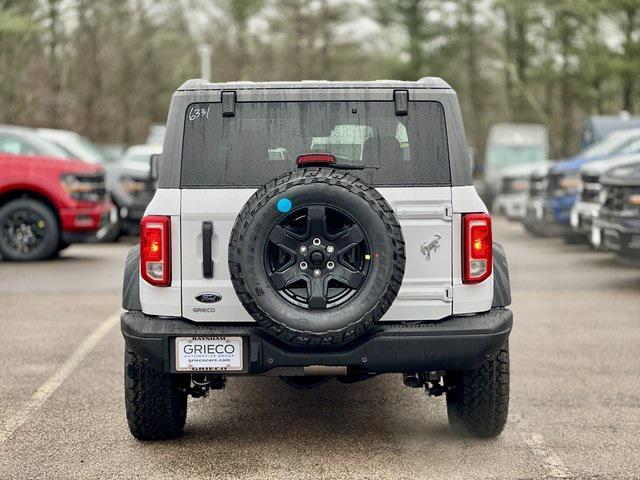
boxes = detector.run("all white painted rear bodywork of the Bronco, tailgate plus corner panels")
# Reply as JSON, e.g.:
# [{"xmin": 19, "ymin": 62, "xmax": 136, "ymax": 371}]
[{"xmin": 140, "ymin": 186, "xmax": 493, "ymax": 322}]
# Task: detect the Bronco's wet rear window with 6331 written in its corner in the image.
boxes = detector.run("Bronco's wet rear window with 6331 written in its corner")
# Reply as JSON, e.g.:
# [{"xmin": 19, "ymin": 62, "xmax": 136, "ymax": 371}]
[{"xmin": 181, "ymin": 101, "xmax": 451, "ymax": 187}]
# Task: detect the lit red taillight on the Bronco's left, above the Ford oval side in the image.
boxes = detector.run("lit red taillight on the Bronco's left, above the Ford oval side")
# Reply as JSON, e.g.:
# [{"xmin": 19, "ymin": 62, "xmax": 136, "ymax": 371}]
[{"xmin": 140, "ymin": 216, "xmax": 171, "ymax": 287}]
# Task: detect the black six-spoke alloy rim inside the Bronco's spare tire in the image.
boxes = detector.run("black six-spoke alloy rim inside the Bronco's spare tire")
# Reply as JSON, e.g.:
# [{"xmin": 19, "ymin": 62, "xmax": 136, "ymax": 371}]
[{"xmin": 264, "ymin": 205, "xmax": 371, "ymax": 310}]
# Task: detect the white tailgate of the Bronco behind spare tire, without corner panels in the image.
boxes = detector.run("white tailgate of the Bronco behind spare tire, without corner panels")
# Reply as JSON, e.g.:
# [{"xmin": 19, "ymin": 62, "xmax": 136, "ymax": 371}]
[{"xmin": 181, "ymin": 187, "xmax": 452, "ymax": 322}]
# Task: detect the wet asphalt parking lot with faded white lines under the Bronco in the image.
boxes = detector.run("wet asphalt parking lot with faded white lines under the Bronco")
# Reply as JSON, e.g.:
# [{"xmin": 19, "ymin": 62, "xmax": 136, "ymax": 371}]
[{"xmin": 0, "ymin": 221, "xmax": 640, "ymax": 479}]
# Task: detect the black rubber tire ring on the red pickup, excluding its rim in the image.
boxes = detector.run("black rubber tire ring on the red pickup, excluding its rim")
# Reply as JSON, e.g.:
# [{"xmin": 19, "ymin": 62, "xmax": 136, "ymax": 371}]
[{"xmin": 0, "ymin": 198, "xmax": 60, "ymax": 262}]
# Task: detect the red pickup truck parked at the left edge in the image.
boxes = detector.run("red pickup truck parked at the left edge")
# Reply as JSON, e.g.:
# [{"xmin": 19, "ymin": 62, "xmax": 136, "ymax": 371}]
[{"xmin": 0, "ymin": 126, "xmax": 116, "ymax": 261}]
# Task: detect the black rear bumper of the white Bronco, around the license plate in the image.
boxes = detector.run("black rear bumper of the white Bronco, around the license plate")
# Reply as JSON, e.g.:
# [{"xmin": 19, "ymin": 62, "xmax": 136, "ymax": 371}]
[{"xmin": 121, "ymin": 308, "xmax": 513, "ymax": 374}]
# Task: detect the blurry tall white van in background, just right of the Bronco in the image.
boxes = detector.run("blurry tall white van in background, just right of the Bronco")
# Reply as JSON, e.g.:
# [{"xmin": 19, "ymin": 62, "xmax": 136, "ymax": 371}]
[{"xmin": 483, "ymin": 123, "xmax": 549, "ymax": 211}]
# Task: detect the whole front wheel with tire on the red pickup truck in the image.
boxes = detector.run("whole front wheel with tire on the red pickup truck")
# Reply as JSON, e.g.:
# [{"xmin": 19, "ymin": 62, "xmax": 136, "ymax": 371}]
[{"xmin": 0, "ymin": 198, "xmax": 60, "ymax": 261}]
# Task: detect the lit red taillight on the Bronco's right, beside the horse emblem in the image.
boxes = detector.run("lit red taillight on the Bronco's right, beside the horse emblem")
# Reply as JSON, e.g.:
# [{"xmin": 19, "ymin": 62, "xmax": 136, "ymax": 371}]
[{"xmin": 462, "ymin": 213, "xmax": 493, "ymax": 283}]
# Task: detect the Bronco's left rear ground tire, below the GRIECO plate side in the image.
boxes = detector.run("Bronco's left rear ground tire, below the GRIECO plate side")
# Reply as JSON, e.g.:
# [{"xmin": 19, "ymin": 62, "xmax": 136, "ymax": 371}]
[{"xmin": 124, "ymin": 348, "xmax": 187, "ymax": 440}]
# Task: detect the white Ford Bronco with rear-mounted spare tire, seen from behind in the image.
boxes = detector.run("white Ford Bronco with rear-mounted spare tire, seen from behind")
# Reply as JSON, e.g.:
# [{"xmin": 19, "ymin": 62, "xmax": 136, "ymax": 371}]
[{"xmin": 122, "ymin": 78, "xmax": 512, "ymax": 439}]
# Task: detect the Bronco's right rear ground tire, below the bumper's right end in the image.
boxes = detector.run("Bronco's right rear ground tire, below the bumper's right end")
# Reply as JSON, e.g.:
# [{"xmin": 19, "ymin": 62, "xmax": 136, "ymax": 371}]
[{"xmin": 447, "ymin": 343, "xmax": 509, "ymax": 438}]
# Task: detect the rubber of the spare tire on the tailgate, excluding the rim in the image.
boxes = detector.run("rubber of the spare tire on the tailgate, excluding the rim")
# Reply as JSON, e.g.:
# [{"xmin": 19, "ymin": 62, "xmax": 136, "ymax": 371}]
[{"xmin": 229, "ymin": 168, "xmax": 405, "ymax": 345}]
